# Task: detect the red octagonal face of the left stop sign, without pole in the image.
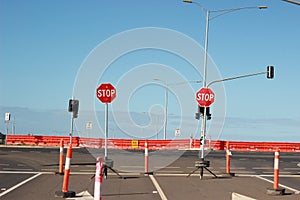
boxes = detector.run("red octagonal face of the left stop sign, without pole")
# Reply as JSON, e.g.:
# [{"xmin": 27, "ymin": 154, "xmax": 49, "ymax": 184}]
[{"xmin": 96, "ymin": 83, "xmax": 117, "ymax": 103}]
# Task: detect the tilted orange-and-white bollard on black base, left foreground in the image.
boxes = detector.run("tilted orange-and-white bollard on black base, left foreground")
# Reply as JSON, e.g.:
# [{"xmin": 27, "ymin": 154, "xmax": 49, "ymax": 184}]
[{"xmin": 55, "ymin": 144, "xmax": 76, "ymax": 198}]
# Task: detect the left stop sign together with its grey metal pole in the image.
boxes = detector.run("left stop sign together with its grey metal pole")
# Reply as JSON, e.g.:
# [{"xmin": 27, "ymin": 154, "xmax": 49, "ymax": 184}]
[{"xmin": 96, "ymin": 83, "xmax": 117, "ymax": 161}]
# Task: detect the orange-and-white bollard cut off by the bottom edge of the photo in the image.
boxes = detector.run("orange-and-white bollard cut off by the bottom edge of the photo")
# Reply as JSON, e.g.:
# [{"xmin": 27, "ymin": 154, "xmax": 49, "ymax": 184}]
[{"xmin": 94, "ymin": 157, "xmax": 103, "ymax": 200}]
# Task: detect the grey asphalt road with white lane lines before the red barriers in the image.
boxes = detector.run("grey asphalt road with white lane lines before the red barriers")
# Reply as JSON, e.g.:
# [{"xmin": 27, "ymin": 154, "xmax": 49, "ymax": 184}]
[{"xmin": 0, "ymin": 146, "xmax": 300, "ymax": 200}]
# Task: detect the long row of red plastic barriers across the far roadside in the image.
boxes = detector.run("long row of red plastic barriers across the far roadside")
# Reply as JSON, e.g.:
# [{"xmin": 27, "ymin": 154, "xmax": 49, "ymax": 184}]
[{"xmin": 6, "ymin": 135, "xmax": 300, "ymax": 152}]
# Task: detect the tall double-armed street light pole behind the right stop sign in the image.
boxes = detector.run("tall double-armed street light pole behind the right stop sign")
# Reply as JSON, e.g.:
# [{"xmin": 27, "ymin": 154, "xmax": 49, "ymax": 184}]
[{"xmin": 183, "ymin": 0, "xmax": 267, "ymax": 179}]
